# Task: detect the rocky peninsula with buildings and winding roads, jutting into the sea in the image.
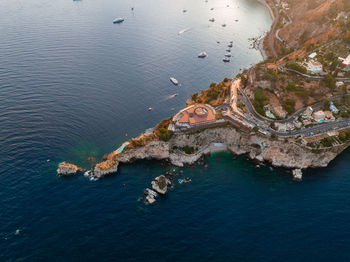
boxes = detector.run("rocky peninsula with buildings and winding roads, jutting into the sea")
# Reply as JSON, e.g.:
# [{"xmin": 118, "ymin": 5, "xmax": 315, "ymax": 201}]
[{"xmin": 57, "ymin": 0, "xmax": 350, "ymax": 178}]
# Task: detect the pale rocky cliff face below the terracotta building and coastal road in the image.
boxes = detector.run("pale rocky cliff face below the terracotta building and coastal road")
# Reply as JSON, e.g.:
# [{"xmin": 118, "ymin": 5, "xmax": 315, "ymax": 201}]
[{"xmin": 106, "ymin": 127, "xmax": 344, "ymax": 172}]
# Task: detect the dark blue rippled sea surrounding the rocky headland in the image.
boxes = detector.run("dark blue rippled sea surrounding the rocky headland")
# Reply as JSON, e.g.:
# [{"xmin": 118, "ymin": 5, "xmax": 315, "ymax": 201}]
[{"xmin": 0, "ymin": 0, "xmax": 350, "ymax": 261}]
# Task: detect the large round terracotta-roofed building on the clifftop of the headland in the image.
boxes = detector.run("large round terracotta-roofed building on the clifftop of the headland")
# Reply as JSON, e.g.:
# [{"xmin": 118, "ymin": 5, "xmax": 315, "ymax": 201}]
[{"xmin": 173, "ymin": 104, "xmax": 216, "ymax": 128}]
